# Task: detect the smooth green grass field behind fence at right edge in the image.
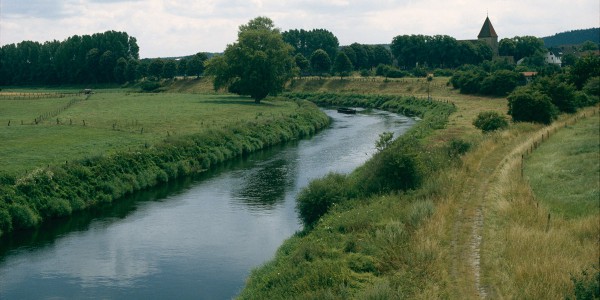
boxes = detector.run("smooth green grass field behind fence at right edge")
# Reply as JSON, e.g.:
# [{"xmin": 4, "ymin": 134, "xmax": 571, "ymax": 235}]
[{"xmin": 525, "ymin": 116, "xmax": 600, "ymax": 218}]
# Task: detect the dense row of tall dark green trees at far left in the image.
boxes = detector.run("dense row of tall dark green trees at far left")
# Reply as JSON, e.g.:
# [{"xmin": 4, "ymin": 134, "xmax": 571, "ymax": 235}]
[{"xmin": 0, "ymin": 31, "xmax": 139, "ymax": 85}]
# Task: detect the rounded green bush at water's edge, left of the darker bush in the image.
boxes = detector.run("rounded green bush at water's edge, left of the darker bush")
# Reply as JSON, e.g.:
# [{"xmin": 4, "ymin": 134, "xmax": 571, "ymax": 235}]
[{"xmin": 296, "ymin": 173, "xmax": 346, "ymax": 228}]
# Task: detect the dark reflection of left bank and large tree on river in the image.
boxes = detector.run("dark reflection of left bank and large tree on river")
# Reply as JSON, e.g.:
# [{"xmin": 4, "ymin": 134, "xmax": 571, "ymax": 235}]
[{"xmin": 0, "ymin": 142, "xmax": 297, "ymax": 262}]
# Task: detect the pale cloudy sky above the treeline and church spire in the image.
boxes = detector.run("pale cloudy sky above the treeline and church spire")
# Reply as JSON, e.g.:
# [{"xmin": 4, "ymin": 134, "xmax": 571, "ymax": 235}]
[{"xmin": 0, "ymin": 0, "xmax": 600, "ymax": 58}]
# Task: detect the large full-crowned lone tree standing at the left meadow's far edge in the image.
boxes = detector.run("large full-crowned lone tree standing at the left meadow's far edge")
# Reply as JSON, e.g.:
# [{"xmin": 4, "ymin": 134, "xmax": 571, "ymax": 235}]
[{"xmin": 212, "ymin": 17, "xmax": 294, "ymax": 103}]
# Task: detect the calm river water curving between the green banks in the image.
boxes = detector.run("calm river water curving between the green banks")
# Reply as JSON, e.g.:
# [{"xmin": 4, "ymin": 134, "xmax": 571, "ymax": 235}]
[{"xmin": 0, "ymin": 110, "xmax": 414, "ymax": 299}]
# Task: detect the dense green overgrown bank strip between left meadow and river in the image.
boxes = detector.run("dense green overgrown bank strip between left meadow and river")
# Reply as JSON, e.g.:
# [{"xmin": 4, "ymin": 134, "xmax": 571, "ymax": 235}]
[{"xmin": 0, "ymin": 101, "xmax": 329, "ymax": 235}]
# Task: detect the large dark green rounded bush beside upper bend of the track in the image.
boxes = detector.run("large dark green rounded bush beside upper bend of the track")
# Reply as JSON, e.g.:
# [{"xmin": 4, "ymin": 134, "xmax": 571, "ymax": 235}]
[{"xmin": 508, "ymin": 87, "xmax": 558, "ymax": 124}]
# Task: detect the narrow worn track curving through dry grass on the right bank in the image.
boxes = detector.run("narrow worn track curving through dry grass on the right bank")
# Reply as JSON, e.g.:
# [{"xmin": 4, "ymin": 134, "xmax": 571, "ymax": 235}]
[{"xmin": 450, "ymin": 107, "xmax": 589, "ymax": 299}]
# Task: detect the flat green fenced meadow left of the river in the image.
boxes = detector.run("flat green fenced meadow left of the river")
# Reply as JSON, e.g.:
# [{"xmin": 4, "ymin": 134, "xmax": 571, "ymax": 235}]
[{"xmin": 0, "ymin": 90, "xmax": 296, "ymax": 175}]
